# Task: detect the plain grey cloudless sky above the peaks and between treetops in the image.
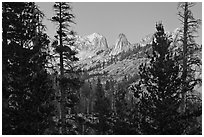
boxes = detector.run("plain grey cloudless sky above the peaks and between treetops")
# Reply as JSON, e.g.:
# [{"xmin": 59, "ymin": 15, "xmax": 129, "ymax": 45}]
[{"xmin": 37, "ymin": 2, "xmax": 202, "ymax": 45}]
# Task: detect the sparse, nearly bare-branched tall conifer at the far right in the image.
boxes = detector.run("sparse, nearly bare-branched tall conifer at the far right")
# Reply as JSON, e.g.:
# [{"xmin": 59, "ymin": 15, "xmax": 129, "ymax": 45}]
[{"xmin": 178, "ymin": 2, "xmax": 202, "ymax": 113}]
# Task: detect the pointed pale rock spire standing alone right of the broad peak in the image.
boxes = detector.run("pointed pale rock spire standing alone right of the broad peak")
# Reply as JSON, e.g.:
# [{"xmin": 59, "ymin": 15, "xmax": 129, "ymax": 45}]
[{"xmin": 110, "ymin": 33, "xmax": 130, "ymax": 55}]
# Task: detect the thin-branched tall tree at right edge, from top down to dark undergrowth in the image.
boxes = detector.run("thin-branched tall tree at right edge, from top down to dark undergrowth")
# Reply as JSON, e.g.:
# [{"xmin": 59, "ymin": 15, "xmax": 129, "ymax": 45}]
[{"xmin": 178, "ymin": 2, "xmax": 202, "ymax": 134}]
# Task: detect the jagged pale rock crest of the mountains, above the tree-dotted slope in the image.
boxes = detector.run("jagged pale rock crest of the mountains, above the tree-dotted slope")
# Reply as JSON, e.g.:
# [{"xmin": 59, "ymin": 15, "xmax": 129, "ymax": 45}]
[{"xmin": 76, "ymin": 29, "xmax": 183, "ymax": 60}]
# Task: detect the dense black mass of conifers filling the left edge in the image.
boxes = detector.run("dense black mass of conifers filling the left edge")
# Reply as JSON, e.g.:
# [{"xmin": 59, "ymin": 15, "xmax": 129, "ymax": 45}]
[{"xmin": 2, "ymin": 2, "xmax": 53, "ymax": 134}]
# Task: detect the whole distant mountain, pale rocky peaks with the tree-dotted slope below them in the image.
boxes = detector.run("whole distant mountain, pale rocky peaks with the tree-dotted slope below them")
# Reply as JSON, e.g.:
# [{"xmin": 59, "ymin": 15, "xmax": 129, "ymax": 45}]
[{"xmin": 74, "ymin": 29, "xmax": 201, "ymax": 86}]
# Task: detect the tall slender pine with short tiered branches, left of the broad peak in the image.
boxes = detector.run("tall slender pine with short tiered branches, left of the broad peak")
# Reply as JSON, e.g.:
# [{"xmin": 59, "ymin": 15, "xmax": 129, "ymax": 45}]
[{"xmin": 52, "ymin": 2, "xmax": 80, "ymax": 134}]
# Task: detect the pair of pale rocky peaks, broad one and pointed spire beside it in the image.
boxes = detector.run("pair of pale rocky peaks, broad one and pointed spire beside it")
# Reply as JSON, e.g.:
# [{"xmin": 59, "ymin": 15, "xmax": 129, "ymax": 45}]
[{"xmin": 76, "ymin": 33, "xmax": 135, "ymax": 59}]
